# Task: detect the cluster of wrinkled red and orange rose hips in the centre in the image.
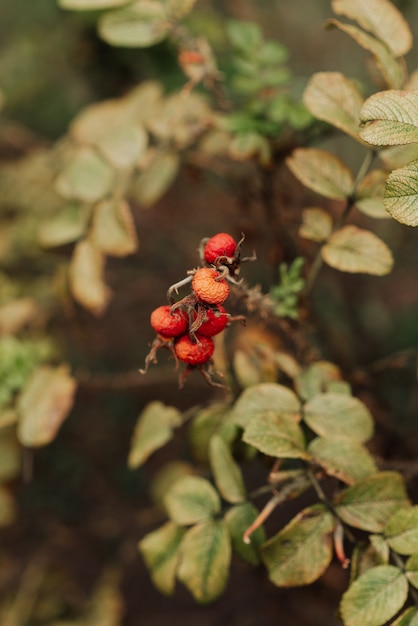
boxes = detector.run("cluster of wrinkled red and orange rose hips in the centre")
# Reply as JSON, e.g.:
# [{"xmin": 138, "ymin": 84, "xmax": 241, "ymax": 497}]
[{"xmin": 140, "ymin": 233, "xmax": 255, "ymax": 386}]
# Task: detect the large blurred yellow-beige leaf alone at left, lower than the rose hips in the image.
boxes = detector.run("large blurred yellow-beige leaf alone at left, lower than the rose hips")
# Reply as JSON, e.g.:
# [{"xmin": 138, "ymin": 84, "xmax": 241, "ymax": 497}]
[{"xmin": 17, "ymin": 365, "xmax": 76, "ymax": 448}]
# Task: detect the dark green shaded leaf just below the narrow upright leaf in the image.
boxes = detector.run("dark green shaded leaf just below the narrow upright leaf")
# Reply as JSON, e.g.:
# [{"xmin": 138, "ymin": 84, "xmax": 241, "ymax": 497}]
[{"xmin": 224, "ymin": 502, "xmax": 266, "ymax": 566}]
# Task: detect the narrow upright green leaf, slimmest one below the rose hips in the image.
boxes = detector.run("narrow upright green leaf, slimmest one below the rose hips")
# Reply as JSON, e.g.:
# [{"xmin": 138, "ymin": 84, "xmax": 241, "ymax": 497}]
[{"xmin": 209, "ymin": 435, "xmax": 245, "ymax": 504}]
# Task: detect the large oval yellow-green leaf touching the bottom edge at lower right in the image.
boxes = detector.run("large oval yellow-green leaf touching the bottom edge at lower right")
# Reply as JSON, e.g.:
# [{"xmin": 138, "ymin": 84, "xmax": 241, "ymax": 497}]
[{"xmin": 340, "ymin": 565, "xmax": 408, "ymax": 626}]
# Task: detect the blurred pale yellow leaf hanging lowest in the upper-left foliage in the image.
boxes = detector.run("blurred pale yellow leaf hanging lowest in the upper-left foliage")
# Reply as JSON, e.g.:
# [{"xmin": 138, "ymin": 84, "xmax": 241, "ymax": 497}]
[{"xmin": 69, "ymin": 239, "xmax": 111, "ymax": 316}]
